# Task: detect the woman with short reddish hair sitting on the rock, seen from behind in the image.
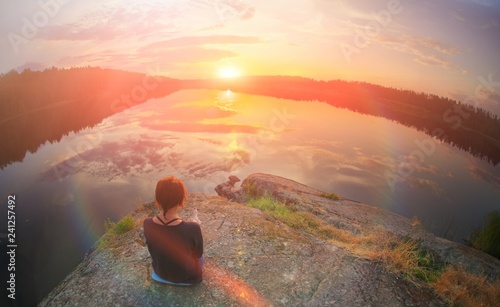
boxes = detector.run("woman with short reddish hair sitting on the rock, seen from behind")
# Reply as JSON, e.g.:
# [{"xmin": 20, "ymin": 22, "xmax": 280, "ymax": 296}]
[{"xmin": 144, "ymin": 176, "xmax": 204, "ymax": 286}]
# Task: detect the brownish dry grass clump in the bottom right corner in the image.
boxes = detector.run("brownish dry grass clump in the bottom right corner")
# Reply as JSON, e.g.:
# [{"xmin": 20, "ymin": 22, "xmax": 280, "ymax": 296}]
[{"xmin": 433, "ymin": 267, "xmax": 500, "ymax": 306}]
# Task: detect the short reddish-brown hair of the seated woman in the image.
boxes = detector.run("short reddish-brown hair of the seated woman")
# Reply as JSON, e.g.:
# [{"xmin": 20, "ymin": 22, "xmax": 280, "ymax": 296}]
[{"xmin": 155, "ymin": 176, "xmax": 186, "ymax": 212}]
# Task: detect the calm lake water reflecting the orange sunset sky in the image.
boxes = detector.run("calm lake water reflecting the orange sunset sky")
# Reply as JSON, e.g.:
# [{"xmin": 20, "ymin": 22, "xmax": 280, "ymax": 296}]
[{"xmin": 0, "ymin": 90, "xmax": 500, "ymax": 304}]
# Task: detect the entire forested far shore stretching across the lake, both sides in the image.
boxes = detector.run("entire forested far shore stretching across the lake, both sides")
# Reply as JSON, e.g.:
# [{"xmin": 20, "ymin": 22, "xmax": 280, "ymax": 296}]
[{"xmin": 0, "ymin": 67, "xmax": 500, "ymax": 168}]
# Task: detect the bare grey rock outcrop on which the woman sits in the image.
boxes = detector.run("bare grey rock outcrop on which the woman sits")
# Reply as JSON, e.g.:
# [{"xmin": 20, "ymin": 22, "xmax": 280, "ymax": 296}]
[{"xmin": 40, "ymin": 174, "xmax": 500, "ymax": 306}]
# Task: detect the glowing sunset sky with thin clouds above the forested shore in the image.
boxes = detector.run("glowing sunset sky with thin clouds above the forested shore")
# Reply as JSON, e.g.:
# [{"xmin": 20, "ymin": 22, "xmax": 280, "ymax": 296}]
[{"xmin": 0, "ymin": 0, "xmax": 500, "ymax": 115}]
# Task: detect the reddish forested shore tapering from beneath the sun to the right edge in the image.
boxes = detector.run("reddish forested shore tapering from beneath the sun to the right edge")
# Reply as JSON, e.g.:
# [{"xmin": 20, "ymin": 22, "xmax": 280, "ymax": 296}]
[{"xmin": 196, "ymin": 76, "xmax": 500, "ymax": 165}]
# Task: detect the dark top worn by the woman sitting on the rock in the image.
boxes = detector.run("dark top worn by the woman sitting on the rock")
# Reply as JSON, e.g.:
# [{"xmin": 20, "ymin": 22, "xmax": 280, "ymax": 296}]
[{"xmin": 144, "ymin": 218, "xmax": 203, "ymax": 283}]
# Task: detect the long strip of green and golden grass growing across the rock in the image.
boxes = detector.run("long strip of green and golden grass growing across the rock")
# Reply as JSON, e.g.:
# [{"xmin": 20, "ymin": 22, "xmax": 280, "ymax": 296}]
[{"xmin": 247, "ymin": 197, "xmax": 500, "ymax": 306}]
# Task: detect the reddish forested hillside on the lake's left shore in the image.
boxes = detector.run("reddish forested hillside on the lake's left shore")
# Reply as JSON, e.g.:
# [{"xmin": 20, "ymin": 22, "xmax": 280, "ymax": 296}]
[{"xmin": 0, "ymin": 67, "xmax": 184, "ymax": 168}]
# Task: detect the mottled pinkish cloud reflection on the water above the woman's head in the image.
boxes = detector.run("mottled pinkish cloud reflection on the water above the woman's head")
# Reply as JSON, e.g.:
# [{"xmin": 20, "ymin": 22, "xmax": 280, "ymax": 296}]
[{"xmin": 40, "ymin": 134, "xmax": 250, "ymax": 183}]
